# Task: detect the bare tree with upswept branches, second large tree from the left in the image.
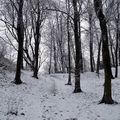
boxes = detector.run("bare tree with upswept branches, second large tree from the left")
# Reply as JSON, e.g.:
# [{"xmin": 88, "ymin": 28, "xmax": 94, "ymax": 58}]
[{"xmin": 27, "ymin": 0, "xmax": 47, "ymax": 78}]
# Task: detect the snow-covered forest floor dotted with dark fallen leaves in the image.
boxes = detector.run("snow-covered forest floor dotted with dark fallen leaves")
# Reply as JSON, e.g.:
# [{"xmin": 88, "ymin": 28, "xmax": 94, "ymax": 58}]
[{"xmin": 0, "ymin": 71, "xmax": 120, "ymax": 120}]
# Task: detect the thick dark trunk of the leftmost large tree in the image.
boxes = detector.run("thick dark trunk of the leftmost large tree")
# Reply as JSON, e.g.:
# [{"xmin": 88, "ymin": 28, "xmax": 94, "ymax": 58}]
[{"xmin": 14, "ymin": 0, "xmax": 24, "ymax": 84}]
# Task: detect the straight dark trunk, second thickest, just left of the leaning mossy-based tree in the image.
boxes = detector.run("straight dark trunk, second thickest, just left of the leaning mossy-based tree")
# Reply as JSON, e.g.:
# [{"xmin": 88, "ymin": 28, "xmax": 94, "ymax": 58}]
[{"xmin": 72, "ymin": 0, "xmax": 82, "ymax": 93}]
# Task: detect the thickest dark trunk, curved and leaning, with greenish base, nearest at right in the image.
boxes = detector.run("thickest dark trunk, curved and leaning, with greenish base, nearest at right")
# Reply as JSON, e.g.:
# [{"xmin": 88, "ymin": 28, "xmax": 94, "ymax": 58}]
[{"xmin": 94, "ymin": 0, "xmax": 114, "ymax": 104}]
